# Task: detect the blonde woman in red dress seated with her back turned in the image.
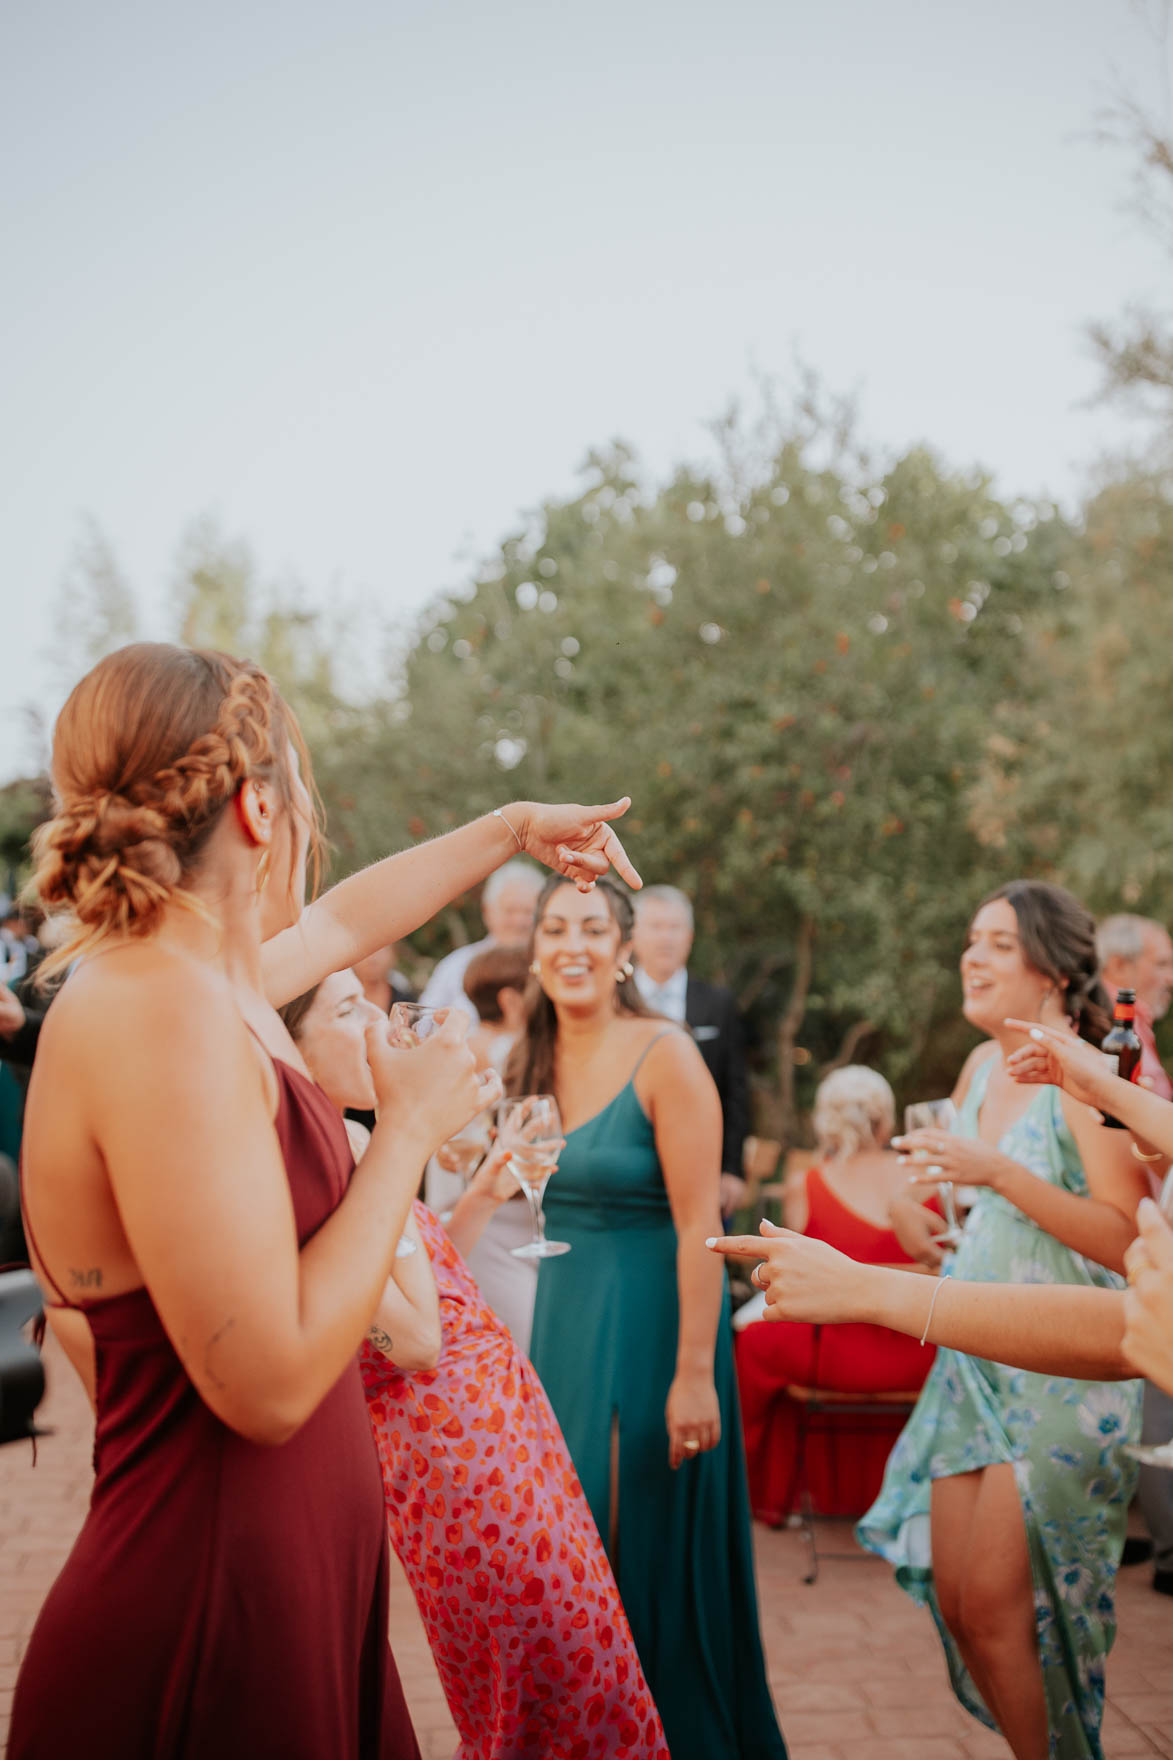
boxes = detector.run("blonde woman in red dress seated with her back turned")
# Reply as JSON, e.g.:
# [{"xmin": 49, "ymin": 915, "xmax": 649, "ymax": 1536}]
[{"xmin": 734, "ymin": 1065, "xmax": 933, "ymax": 1526}]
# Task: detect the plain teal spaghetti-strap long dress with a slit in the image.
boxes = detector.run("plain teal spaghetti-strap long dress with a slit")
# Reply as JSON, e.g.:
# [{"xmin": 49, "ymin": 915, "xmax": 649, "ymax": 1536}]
[{"xmin": 530, "ymin": 1040, "xmax": 786, "ymax": 1760}]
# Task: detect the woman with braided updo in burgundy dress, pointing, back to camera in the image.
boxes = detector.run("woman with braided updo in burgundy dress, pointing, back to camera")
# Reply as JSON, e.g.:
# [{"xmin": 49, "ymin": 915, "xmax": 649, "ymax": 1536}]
[{"xmin": 9, "ymin": 642, "xmax": 638, "ymax": 1760}]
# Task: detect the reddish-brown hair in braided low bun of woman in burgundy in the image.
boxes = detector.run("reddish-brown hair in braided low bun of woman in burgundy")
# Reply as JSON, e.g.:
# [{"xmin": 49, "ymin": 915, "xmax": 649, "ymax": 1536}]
[{"xmin": 33, "ymin": 642, "xmax": 321, "ymax": 977}]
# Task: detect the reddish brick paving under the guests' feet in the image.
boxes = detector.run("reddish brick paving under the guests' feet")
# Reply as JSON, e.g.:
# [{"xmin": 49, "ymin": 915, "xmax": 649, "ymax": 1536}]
[{"xmin": 0, "ymin": 1345, "xmax": 1173, "ymax": 1760}]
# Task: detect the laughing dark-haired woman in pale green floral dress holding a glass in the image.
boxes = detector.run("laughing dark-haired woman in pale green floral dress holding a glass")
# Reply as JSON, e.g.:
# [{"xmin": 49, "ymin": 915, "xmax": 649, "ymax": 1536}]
[{"xmin": 858, "ymin": 880, "xmax": 1145, "ymax": 1760}]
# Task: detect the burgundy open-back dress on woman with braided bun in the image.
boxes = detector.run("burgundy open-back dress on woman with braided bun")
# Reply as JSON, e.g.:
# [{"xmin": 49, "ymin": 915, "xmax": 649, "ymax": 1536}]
[{"xmin": 9, "ymin": 1061, "xmax": 419, "ymax": 1760}]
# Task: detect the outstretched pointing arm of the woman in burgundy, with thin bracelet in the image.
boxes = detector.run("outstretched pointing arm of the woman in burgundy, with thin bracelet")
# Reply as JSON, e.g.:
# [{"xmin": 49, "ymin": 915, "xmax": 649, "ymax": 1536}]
[{"xmin": 262, "ymin": 797, "xmax": 641, "ymax": 1008}]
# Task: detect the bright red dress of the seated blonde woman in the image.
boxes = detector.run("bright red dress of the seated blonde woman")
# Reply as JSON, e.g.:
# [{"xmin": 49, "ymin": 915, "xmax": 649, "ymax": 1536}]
[{"xmin": 734, "ymin": 1167, "xmax": 935, "ymax": 1524}]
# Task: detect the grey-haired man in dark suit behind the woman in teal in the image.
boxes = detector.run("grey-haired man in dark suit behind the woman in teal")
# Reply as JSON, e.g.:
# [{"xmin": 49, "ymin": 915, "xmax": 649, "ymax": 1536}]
[{"xmin": 632, "ymin": 885, "xmax": 749, "ymax": 1216}]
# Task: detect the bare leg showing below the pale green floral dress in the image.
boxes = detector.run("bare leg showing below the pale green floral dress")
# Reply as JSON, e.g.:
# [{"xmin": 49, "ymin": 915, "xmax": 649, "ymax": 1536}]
[{"xmin": 960, "ymin": 1464, "xmax": 1050, "ymax": 1760}]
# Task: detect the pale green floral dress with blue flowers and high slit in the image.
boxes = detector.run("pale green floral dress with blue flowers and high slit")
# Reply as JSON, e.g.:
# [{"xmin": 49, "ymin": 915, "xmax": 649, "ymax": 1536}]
[{"xmin": 856, "ymin": 1058, "xmax": 1141, "ymax": 1760}]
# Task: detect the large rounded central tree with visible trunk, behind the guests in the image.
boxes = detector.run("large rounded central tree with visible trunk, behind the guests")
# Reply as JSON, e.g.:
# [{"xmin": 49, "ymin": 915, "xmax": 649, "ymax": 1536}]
[{"xmin": 320, "ymin": 419, "xmax": 1067, "ymax": 1132}]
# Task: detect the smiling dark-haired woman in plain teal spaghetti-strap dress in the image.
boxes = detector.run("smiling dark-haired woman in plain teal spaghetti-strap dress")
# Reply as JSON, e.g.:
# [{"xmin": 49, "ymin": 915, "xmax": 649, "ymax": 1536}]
[{"xmin": 507, "ymin": 880, "xmax": 786, "ymax": 1760}]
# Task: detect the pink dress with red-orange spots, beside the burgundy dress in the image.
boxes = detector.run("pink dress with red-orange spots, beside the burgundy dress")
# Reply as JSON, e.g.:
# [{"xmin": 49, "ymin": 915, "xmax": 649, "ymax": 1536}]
[{"xmin": 361, "ymin": 1204, "xmax": 668, "ymax": 1760}]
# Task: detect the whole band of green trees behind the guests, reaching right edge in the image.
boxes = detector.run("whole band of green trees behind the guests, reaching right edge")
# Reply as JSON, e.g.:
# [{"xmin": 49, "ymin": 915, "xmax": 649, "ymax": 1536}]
[{"xmin": 15, "ymin": 396, "xmax": 1173, "ymax": 1140}]
